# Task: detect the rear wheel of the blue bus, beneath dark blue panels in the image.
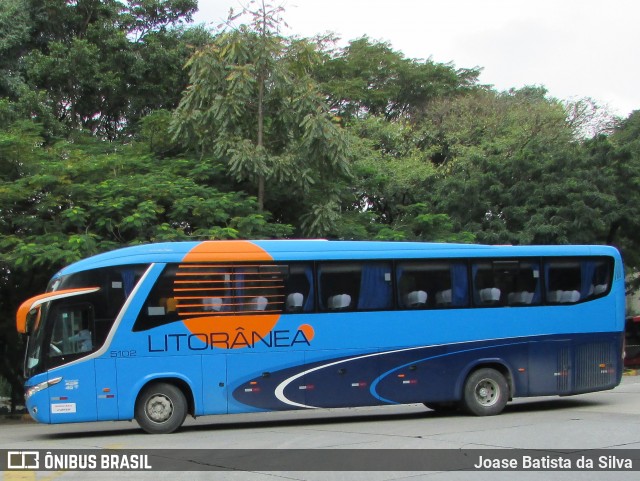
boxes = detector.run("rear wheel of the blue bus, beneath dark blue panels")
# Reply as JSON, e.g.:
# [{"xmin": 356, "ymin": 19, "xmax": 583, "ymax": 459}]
[{"xmin": 463, "ymin": 368, "xmax": 509, "ymax": 416}]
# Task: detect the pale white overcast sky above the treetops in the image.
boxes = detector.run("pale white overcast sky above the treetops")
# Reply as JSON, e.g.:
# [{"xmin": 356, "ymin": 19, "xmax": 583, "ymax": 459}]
[{"xmin": 194, "ymin": 0, "xmax": 640, "ymax": 117}]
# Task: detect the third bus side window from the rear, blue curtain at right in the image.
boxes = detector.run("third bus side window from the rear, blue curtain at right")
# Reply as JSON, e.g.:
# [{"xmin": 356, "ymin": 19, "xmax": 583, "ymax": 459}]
[{"xmin": 396, "ymin": 261, "xmax": 468, "ymax": 309}]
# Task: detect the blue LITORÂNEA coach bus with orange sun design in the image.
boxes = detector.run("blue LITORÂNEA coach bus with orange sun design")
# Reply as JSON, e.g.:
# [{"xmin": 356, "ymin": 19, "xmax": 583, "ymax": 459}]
[{"xmin": 17, "ymin": 240, "xmax": 625, "ymax": 433}]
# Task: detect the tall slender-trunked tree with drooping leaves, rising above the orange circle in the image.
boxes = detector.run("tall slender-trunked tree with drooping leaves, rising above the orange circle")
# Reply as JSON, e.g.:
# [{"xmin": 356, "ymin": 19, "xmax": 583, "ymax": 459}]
[{"xmin": 173, "ymin": 3, "xmax": 349, "ymax": 235}]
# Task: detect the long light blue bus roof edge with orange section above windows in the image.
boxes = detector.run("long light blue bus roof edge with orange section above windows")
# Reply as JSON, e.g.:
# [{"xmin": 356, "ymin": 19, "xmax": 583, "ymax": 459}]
[{"xmin": 56, "ymin": 240, "xmax": 619, "ymax": 277}]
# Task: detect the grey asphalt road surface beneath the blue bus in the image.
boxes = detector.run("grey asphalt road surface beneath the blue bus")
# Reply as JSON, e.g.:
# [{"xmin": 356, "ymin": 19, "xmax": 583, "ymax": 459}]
[{"xmin": 0, "ymin": 376, "xmax": 640, "ymax": 481}]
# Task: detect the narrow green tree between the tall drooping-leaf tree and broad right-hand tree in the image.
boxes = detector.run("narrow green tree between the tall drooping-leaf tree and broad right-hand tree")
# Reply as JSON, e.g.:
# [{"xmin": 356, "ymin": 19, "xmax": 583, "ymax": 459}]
[{"xmin": 335, "ymin": 115, "xmax": 474, "ymax": 242}]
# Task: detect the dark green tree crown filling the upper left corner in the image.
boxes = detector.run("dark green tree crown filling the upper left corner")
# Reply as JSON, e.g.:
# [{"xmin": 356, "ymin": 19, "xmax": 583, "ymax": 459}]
[{"xmin": 0, "ymin": 0, "xmax": 208, "ymax": 141}]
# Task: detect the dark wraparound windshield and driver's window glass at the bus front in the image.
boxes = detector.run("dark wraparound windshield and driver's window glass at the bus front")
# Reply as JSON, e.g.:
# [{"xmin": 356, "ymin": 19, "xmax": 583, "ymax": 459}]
[{"xmin": 24, "ymin": 266, "xmax": 146, "ymax": 377}]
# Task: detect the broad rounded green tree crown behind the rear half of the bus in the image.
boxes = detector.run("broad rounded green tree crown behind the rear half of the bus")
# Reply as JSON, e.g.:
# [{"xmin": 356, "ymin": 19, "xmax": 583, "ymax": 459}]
[{"xmin": 408, "ymin": 87, "xmax": 634, "ymax": 256}]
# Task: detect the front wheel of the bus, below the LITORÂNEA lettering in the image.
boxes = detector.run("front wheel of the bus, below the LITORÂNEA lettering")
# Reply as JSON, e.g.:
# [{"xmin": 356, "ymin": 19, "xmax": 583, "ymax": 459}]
[{"xmin": 135, "ymin": 383, "xmax": 187, "ymax": 434}]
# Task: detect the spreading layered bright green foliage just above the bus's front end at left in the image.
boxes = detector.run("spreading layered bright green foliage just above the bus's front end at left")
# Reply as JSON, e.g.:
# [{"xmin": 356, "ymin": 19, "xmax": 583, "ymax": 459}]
[{"xmin": 1, "ymin": 133, "xmax": 288, "ymax": 249}]
